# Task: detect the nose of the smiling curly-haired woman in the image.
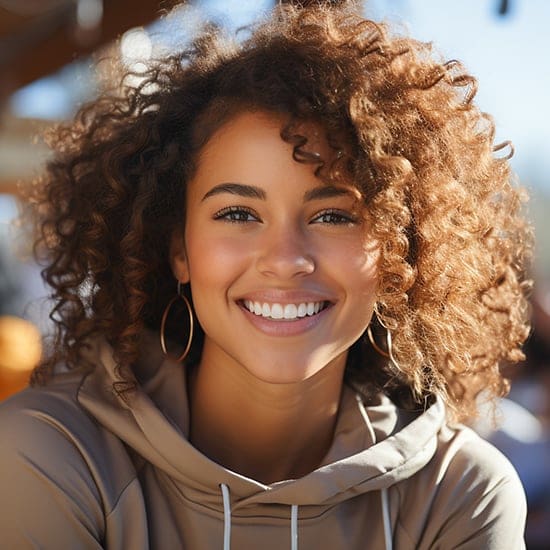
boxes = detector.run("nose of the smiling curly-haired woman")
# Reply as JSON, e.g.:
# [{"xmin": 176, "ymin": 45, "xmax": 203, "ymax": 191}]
[{"xmin": 256, "ymin": 226, "xmax": 315, "ymax": 279}]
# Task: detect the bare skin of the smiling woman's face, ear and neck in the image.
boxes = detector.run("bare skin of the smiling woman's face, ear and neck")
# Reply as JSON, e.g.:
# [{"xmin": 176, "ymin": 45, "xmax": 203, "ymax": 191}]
[{"xmin": 171, "ymin": 111, "xmax": 378, "ymax": 483}]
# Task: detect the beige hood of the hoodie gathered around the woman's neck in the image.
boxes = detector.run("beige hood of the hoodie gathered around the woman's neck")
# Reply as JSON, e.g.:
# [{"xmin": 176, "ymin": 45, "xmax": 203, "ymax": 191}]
[{"xmin": 78, "ymin": 334, "xmax": 445, "ymax": 514}]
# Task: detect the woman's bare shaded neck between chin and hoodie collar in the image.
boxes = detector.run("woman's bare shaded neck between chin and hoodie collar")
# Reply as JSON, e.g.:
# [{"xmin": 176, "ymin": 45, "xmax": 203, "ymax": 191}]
[{"xmin": 190, "ymin": 357, "xmax": 345, "ymax": 484}]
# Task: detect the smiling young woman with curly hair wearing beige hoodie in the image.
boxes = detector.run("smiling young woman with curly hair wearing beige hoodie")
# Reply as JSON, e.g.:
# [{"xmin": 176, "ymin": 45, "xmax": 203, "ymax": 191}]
[{"xmin": 0, "ymin": 2, "xmax": 529, "ymax": 550}]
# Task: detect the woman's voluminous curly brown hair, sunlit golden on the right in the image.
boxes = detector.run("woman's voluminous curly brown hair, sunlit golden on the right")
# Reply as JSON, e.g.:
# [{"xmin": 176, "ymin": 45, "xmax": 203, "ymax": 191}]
[{"xmin": 24, "ymin": 5, "xmax": 531, "ymax": 419}]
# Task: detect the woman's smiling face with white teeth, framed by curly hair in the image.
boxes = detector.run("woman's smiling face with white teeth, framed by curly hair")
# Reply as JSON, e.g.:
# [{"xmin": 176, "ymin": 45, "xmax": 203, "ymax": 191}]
[{"xmin": 172, "ymin": 111, "xmax": 378, "ymax": 383}]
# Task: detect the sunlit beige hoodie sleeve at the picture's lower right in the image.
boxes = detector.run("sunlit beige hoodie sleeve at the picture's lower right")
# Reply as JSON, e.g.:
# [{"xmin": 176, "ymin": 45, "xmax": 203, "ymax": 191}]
[{"xmin": 408, "ymin": 429, "xmax": 527, "ymax": 550}]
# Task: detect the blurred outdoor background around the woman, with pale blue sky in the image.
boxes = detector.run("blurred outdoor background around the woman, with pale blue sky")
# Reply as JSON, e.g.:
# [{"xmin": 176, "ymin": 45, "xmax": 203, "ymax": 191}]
[{"xmin": 0, "ymin": 0, "xmax": 550, "ymax": 549}]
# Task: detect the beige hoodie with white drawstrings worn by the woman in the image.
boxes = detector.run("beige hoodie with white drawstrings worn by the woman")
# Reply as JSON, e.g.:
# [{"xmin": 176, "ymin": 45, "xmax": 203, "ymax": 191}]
[{"xmin": 0, "ymin": 334, "xmax": 526, "ymax": 550}]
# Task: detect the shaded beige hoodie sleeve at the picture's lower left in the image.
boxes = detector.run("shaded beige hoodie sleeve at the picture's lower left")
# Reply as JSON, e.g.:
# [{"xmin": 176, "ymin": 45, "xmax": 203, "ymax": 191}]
[{"xmin": 0, "ymin": 390, "xmax": 105, "ymax": 550}]
